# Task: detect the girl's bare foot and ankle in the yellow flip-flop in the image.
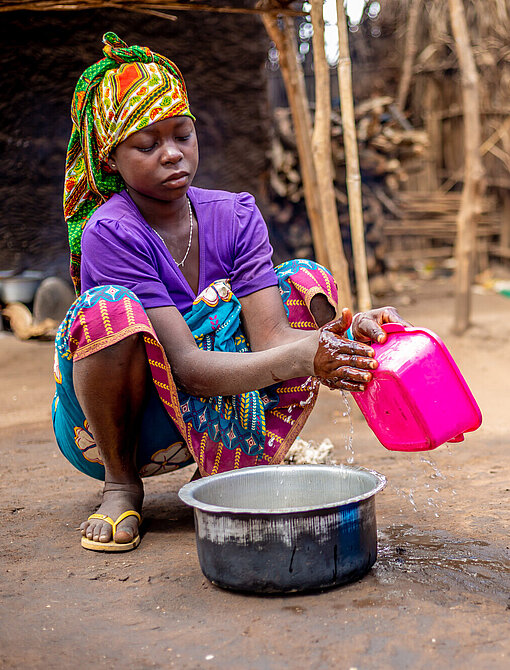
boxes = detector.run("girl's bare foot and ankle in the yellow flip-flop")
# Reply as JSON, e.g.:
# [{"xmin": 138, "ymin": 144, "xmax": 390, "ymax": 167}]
[{"xmin": 80, "ymin": 481, "xmax": 143, "ymax": 544}]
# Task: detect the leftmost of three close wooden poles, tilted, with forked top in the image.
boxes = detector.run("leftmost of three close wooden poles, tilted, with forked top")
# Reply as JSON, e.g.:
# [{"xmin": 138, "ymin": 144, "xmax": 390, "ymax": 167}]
[{"xmin": 262, "ymin": 14, "xmax": 329, "ymax": 267}]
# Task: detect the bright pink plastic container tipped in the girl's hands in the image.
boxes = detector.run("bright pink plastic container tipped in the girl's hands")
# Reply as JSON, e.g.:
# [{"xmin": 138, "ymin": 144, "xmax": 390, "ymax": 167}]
[{"xmin": 352, "ymin": 323, "xmax": 482, "ymax": 451}]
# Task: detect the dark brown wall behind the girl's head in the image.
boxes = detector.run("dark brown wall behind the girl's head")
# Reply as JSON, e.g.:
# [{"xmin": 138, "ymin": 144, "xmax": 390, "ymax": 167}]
[{"xmin": 0, "ymin": 10, "xmax": 268, "ymax": 275}]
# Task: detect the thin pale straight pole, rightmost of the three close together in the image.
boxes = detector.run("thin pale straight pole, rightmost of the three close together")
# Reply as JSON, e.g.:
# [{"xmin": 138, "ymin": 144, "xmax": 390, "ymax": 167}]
[{"xmin": 336, "ymin": 0, "xmax": 372, "ymax": 312}]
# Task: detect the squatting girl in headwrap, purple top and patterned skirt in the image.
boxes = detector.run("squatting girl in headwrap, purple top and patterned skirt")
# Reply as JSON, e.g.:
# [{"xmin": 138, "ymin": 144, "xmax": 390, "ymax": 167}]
[{"xmin": 53, "ymin": 33, "xmax": 402, "ymax": 551}]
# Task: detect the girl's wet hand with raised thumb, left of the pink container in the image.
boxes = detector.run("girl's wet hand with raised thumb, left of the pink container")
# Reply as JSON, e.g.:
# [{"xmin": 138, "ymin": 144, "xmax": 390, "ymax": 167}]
[{"xmin": 313, "ymin": 308, "xmax": 378, "ymax": 392}]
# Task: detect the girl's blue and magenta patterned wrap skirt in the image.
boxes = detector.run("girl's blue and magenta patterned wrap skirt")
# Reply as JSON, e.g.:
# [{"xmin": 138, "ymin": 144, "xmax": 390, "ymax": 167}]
[{"xmin": 53, "ymin": 260, "xmax": 337, "ymax": 480}]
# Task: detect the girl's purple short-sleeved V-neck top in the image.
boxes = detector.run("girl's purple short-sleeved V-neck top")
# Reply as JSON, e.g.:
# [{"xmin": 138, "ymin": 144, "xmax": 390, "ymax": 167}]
[{"xmin": 81, "ymin": 187, "xmax": 278, "ymax": 314}]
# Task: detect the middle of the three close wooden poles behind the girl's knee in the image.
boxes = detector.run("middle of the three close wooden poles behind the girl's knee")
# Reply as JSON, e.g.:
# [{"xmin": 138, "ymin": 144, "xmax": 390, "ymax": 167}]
[{"xmin": 311, "ymin": 0, "xmax": 352, "ymax": 307}]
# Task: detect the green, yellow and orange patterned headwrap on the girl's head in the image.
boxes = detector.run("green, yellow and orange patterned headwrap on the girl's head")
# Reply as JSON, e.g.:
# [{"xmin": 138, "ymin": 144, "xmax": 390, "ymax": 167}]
[{"xmin": 64, "ymin": 33, "xmax": 195, "ymax": 295}]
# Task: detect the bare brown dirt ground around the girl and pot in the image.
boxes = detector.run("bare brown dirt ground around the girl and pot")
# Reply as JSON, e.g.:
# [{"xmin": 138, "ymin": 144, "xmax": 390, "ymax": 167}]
[{"xmin": 0, "ymin": 280, "xmax": 510, "ymax": 670}]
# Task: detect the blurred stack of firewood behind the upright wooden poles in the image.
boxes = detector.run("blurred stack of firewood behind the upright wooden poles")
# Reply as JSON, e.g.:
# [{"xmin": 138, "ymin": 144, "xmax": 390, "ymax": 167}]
[{"xmin": 270, "ymin": 97, "xmax": 428, "ymax": 272}]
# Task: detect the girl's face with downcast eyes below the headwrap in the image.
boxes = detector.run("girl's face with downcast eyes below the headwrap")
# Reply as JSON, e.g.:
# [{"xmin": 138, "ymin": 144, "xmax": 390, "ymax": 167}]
[{"xmin": 108, "ymin": 116, "xmax": 198, "ymax": 202}]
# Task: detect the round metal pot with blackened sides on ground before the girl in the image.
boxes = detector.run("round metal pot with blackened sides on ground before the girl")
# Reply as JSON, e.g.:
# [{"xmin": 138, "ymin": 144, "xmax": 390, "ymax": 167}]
[{"xmin": 179, "ymin": 465, "xmax": 386, "ymax": 593}]
